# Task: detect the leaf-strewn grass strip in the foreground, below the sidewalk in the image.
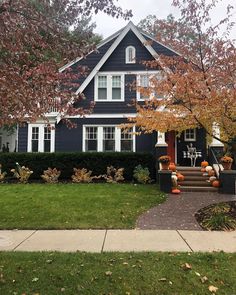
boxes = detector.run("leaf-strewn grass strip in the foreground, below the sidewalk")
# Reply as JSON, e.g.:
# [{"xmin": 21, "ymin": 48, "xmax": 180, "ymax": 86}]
[{"xmin": 0, "ymin": 252, "xmax": 236, "ymax": 295}]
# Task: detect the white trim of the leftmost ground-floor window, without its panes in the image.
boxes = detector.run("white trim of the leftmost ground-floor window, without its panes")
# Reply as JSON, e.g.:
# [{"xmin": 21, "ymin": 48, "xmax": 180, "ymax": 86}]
[{"xmin": 27, "ymin": 124, "xmax": 55, "ymax": 153}]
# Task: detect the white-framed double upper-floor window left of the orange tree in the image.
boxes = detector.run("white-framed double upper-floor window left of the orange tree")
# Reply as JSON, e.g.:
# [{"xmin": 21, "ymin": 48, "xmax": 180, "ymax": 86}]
[{"xmin": 94, "ymin": 73, "xmax": 125, "ymax": 102}]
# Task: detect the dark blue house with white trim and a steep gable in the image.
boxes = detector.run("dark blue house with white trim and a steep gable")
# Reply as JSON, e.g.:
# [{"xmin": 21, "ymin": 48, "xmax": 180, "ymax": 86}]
[{"xmin": 18, "ymin": 22, "xmax": 223, "ymax": 165}]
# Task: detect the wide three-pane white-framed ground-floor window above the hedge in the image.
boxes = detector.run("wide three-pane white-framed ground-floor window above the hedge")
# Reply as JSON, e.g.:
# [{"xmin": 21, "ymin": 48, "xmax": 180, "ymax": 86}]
[{"xmin": 83, "ymin": 125, "xmax": 135, "ymax": 152}]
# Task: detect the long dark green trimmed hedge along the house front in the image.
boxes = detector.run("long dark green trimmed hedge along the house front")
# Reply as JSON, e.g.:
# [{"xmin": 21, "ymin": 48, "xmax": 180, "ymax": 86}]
[{"xmin": 0, "ymin": 152, "xmax": 155, "ymax": 180}]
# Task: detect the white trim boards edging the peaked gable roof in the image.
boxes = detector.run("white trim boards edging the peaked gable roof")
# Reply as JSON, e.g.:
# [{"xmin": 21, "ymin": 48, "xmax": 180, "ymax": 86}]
[{"xmin": 59, "ymin": 21, "xmax": 179, "ymax": 94}]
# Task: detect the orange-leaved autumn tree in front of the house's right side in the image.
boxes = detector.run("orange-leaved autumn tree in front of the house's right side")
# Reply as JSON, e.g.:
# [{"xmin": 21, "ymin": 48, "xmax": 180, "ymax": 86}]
[{"xmin": 130, "ymin": 0, "xmax": 236, "ymax": 148}]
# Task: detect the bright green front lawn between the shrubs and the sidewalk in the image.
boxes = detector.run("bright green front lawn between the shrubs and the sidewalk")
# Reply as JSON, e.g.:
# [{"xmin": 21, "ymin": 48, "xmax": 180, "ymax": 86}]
[{"xmin": 0, "ymin": 183, "xmax": 165, "ymax": 229}]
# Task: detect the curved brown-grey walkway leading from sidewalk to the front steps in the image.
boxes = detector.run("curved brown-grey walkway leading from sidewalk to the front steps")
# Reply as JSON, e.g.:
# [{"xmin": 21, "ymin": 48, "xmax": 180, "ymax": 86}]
[{"xmin": 136, "ymin": 192, "xmax": 236, "ymax": 230}]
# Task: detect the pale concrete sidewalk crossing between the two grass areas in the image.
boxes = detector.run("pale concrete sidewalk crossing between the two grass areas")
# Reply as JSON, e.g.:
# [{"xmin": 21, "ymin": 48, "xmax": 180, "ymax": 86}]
[{"xmin": 0, "ymin": 230, "xmax": 236, "ymax": 253}]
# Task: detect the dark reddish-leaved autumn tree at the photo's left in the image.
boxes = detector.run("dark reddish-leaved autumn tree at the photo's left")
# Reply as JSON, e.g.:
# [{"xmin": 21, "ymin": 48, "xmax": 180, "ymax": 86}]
[{"xmin": 0, "ymin": 0, "xmax": 131, "ymax": 126}]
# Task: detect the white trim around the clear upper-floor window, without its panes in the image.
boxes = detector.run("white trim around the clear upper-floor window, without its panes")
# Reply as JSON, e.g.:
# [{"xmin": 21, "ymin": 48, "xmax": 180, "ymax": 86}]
[{"xmin": 94, "ymin": 72, "xmax": 125, "ymax": 102}]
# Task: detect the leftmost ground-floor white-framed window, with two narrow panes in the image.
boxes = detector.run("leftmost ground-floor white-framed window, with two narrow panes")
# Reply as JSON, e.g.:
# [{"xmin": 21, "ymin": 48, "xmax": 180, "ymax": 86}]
[{"xmin": 27, "ymin": 124, "xmax": 55, "ymax": 153}]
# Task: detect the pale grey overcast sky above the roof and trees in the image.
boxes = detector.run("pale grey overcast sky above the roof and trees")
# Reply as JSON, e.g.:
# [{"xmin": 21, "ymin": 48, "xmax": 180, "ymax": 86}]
[{"xmin": 93, "ymin": 0, "xmax": 236, "ymax": 38}]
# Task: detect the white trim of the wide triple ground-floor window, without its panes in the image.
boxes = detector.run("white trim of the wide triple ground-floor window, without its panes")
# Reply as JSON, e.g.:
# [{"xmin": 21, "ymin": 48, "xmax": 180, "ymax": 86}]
[{"xmin": 82, "ymin": 124, "xmax": 136, "ymax": 153}]
